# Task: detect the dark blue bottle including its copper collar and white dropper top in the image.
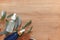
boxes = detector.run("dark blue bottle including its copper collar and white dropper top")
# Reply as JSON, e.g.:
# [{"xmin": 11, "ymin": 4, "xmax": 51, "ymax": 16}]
[{"xmin": 4, "ymin": 29, "xmax": 25, "ymax": 40}]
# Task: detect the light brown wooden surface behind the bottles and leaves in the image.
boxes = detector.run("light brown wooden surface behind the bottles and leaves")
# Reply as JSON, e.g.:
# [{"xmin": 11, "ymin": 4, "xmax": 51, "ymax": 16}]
[{"xmin": 0, "ymin": 0, "xmax": 60, "ymax": 40}]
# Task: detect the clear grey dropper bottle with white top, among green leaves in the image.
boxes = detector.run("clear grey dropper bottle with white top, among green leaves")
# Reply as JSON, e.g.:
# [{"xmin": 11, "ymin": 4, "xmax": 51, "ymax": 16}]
[{"xmin": 6, "ymin": 13, "xmax": 16, "ymax": 33}]
